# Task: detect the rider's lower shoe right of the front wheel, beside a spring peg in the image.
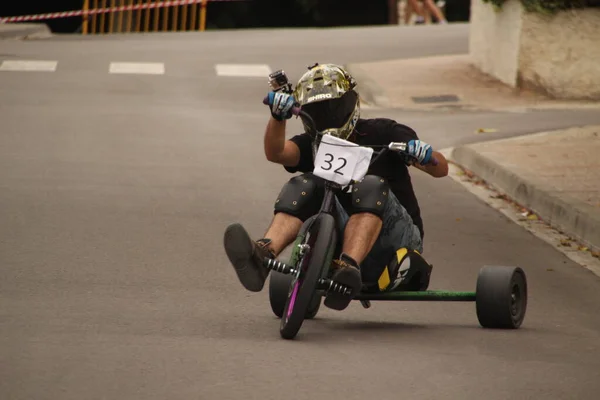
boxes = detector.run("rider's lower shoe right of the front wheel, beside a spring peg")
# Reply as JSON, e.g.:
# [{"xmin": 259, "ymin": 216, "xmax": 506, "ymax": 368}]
[{"xmin": 323, "ymin": 253, "xmax": 362, "ymax": 311}]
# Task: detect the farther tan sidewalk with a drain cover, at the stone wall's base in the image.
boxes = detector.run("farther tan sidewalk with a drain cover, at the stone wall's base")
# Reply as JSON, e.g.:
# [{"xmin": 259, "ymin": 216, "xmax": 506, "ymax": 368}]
[{"xmin": 346, "ymin": 55, "xmax": 600, "ymax": 112}]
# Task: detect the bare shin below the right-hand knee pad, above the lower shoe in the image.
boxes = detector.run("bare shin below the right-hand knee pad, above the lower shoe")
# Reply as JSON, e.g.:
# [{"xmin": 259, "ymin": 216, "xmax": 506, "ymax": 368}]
[{"xmin": 343, "ymin": 213, "xmax": 383, "ymax": 265}]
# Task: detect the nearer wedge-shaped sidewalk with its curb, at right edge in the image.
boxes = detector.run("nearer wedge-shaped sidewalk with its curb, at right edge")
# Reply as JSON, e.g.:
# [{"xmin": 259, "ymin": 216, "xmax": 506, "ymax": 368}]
[{"xmin": 448, "ymin": 125, "xmax": 600, "ymax": 254}]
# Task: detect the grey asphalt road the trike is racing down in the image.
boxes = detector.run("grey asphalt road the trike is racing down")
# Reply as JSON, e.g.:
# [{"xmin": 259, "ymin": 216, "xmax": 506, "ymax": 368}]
[{"xmin": 0, "ymin": 26, "xmax": 600, "ymax": 400}]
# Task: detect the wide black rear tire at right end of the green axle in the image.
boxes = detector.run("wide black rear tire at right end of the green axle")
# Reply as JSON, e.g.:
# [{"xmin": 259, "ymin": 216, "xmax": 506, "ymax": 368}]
[{"xmin": 475, "ymin": 265, "xmax": 527, "ymax": 329}]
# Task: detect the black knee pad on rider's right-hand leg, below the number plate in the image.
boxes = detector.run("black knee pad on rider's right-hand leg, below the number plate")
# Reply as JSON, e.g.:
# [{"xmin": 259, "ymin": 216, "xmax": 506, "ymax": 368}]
[{"xmin": 349, "ymin": 175, "xmax": 390, "ymax": 218}]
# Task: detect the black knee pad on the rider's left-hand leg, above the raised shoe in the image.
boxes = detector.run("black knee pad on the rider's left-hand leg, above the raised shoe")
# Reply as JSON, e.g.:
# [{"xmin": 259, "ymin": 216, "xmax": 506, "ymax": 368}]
[{"xmin": 275, "ymin": 173, "xmax": 325, "ymax": 222}]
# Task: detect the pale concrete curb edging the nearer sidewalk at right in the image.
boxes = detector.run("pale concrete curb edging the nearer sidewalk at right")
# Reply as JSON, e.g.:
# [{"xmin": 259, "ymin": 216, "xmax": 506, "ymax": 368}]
[{"xmin": 447, "ymin": 145, "xmax": 600, "ymax": 251}]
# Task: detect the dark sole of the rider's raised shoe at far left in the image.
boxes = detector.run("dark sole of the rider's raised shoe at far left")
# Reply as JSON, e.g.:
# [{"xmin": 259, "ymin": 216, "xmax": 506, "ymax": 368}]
[{"xmin": 223, "ymin": 224, "xmax": 265, "ymax": 292}]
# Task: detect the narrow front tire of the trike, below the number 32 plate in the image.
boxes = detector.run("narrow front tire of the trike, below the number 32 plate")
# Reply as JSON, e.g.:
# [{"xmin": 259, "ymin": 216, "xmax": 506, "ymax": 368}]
[{"xmin": 279, "ymin": 214, "xmax": 337, "ymax": 339}]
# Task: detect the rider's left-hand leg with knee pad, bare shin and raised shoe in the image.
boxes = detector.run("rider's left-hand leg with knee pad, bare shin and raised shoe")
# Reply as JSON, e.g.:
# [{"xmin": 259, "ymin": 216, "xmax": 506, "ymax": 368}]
[{"xmin": 224, "ymin": 174, "xmax": 324, "ymax": 292}]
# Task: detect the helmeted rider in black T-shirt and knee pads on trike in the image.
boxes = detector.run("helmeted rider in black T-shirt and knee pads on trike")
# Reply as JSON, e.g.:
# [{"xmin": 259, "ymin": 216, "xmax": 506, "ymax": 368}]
[{"xmin": 224, "ymin": 64, "xmax": 448, "ymax": 310}]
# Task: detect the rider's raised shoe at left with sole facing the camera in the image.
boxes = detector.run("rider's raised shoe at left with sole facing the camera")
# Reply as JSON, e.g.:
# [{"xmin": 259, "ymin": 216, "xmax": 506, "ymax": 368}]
[{"xmin": 223, "ymin": 224, "xmax": 275, "ymax": 292}]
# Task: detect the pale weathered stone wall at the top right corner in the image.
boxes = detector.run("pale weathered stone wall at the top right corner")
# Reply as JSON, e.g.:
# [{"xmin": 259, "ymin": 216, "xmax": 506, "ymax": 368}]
[{"xmin": 469, "ymin": 0, "xmax": 600, "ymax": 100}]
